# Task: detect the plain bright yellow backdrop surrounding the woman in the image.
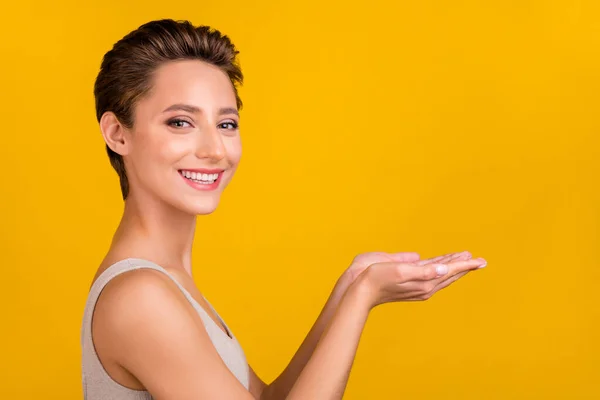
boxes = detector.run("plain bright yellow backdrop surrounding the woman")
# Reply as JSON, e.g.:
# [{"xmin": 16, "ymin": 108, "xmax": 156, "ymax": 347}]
[{"xmin": 0, "ymin": 0, "xmax": 600, "ymax": 399}]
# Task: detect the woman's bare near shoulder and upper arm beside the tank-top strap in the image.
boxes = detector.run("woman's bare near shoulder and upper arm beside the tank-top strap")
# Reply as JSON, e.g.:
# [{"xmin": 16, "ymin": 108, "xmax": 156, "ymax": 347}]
[{"xmin": 94, "ymin": 269, "xmax": 252, "ymax": 400}]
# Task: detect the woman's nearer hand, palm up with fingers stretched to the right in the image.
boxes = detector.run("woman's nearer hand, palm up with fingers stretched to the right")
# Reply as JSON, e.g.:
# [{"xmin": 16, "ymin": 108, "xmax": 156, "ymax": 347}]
[{"xmin": 352, "ymin": 253, "xmax": 486, "ymax": 308}]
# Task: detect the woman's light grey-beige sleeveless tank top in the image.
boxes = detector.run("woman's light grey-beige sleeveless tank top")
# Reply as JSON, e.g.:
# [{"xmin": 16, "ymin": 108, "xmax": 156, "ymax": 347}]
[{"xmin": 81, "ymin": 258, "xmax": 249, "ymax": 400}]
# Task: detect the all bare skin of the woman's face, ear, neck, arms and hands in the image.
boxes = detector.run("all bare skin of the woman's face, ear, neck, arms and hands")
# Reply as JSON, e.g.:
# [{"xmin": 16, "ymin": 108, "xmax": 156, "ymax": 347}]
[{"xmin": 92, "ymin": 60, "xmax": 485, "ymax": 400}]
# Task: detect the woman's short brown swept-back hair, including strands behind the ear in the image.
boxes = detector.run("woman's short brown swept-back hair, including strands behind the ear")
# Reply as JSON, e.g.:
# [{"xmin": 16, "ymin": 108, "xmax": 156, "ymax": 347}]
[{"xmin": 94, "ymin": 19, "xmax": 243, "ymax": 200}]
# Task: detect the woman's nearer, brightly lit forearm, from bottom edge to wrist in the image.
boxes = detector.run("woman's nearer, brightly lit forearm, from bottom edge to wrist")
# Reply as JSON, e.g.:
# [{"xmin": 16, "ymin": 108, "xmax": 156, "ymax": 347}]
[{"xmin": 286, "ymin": 287, "xmax": 370, "ymax": 400}]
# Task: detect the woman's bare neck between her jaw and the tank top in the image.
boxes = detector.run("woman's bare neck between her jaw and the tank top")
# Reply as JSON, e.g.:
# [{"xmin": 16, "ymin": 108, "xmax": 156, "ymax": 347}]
[{"xmin": 111, "ymin": 193, "xmax": 196, "ymax": 276}]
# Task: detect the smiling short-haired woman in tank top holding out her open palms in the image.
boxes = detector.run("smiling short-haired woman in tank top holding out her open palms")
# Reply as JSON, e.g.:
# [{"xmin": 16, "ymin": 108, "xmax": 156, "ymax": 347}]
[{"xmin": 81, "ymin": 20, "xmax": 485, "ymax": 400}]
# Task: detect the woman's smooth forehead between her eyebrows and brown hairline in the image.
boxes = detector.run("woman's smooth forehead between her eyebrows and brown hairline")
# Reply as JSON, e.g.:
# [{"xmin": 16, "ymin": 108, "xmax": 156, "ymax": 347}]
[{"xmin": 140, "ymin": 60, "xmax": 236, "ymax": 111}]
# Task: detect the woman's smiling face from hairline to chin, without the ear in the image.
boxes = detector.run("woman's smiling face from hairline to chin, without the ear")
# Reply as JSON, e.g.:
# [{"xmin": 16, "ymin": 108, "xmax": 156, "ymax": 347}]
[{"xmin": 124, "ymin": 60, "xmax": 242, "ymax": 214}]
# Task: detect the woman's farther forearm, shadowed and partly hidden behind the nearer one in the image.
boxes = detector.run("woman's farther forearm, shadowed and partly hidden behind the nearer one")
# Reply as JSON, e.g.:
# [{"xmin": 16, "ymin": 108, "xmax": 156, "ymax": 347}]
[{"xmin": 261, "ymin": 276, "xmax": 350, "ymax": 400}]
